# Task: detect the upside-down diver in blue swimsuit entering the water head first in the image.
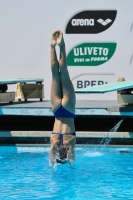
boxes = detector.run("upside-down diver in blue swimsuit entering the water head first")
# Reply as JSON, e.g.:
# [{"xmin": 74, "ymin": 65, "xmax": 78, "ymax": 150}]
[{"xmin": 50, "ymin": 30, "xmax": 76, "ymax": 167}]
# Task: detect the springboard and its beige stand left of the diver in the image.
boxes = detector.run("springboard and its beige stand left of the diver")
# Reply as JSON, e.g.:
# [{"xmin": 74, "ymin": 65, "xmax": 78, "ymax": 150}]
[{"xmin": 0, "ymin": 78, "xmax": 44, "ymax": 103}]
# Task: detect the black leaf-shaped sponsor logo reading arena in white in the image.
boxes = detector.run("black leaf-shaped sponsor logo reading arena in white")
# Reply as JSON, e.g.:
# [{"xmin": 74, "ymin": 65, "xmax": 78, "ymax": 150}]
[{"xmin": 66, "ymin": 10, "xmax": 117, "ymax": 34}]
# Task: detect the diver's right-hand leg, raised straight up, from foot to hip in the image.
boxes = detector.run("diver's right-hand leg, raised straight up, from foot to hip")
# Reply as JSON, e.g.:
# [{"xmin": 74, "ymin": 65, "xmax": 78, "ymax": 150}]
[{"xmin": 58, "ymin": 32, "xmax": 76, "ymax": 113}]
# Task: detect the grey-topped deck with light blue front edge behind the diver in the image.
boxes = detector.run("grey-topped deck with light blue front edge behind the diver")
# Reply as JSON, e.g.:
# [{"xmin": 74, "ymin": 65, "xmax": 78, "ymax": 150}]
[{"xmin": 0, "ymin": 100, "xmax": 133, "ymax": 117}]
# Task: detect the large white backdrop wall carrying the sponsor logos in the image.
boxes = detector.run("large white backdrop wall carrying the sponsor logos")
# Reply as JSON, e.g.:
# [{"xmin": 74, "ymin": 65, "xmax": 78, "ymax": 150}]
[{"xmin": 0, "ymin": 0, "xmax": 133, "ymax": 100}]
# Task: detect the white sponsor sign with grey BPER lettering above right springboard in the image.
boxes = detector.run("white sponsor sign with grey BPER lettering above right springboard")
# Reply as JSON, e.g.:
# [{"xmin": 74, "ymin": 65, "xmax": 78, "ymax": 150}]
[{"xmin": 71, "ymin": 73, "xmax": 115, "ymax": 90}]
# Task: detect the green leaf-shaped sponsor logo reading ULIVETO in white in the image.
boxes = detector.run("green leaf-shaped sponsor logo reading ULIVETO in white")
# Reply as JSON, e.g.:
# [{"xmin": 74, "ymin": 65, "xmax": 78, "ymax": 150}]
[{"xmin": 67, "ymin": 43, "xmax": 117, "ymax": 66}]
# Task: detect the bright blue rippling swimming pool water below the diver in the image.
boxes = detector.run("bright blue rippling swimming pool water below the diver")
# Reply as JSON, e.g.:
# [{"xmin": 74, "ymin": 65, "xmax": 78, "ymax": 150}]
[{"xmin": 0, "ymin": 146, "xmax": 133, "ymax": 200}]
